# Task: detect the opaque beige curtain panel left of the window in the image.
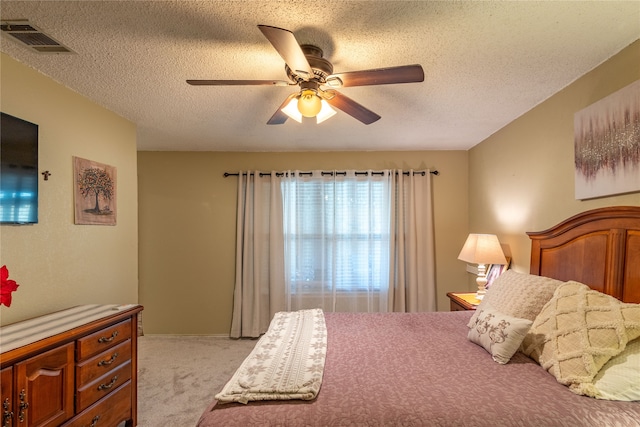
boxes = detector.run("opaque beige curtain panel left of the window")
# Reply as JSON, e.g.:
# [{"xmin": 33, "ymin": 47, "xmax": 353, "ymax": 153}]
[{"xmin": 230, "ymin": 172, "xmax": 285, "ymax": 338}]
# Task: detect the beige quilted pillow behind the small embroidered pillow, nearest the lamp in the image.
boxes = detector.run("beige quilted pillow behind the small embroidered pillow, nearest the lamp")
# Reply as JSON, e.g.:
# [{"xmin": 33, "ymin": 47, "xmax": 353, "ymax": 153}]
[{"xmin": 468, "ymin": 270, "xmax": 563, "ymax": 327}]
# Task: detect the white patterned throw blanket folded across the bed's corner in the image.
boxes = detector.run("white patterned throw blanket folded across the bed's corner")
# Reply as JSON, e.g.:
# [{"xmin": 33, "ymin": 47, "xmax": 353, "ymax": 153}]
[{"xmin": 216, "ymin": 309, "xmax": 327, "ymax": 403}]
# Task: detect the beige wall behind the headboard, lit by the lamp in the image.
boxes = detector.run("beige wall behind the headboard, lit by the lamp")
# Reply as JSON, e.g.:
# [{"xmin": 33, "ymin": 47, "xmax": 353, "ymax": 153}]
[{"xmin": 469, "ymin": 41, "xmax": 640, "ymax": 272}]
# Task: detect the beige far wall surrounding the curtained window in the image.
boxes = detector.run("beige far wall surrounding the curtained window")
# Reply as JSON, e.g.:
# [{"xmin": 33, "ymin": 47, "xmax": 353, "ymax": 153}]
[{"xmin": 138, "ymin": 151, "xmax": 468, "ymax": 335}]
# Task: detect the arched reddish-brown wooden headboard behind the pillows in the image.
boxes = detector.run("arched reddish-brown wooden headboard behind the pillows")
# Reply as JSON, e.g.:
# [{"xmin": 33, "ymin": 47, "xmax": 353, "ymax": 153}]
[{"xmin": 527, "ymin": 206, "xmax": 640, "ymax": 303}]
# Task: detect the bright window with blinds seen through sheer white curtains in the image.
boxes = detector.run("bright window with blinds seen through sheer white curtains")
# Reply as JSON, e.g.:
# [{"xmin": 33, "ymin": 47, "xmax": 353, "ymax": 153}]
[{"xmin": 282, "ymin": 173, "xmax": 390, "ymax": 294}]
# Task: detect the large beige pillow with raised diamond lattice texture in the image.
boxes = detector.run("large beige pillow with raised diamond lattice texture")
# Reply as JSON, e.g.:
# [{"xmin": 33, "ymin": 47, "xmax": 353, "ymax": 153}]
[{"xmin": 522, "ymin": 282, "xmax": 640, "ymax": 397}]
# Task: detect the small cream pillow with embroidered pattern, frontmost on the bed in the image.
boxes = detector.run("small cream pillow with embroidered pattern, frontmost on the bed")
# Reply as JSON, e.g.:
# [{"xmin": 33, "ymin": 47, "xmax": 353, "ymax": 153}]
[{"xmin": 467, "ymin": 304, "xmax": 533, "ymax": 365}]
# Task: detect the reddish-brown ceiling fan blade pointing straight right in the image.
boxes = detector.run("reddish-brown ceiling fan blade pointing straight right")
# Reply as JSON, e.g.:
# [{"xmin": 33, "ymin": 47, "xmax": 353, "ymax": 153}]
[{"xmin": 327, "ymin": 64, "xmax": 424, "ymax": 87}]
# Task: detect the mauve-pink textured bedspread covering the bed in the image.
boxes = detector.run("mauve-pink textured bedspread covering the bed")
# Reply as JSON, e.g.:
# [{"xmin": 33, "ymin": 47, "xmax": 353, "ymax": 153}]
[{"xmin": 198, "ymin": 311, "xmax": 640, "ymax": 427}]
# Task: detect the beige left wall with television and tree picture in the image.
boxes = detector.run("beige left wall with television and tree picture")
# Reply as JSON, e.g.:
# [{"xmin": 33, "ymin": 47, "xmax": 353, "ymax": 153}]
[{"xmin": 0, "ymin": 54, "xmax": 138, "ymax": 324}]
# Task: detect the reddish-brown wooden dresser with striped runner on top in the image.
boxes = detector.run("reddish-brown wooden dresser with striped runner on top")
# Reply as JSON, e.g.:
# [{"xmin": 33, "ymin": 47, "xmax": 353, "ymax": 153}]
[{"xmin": 0, "ymin": 304, "xmax": 142, "ymax": 427}]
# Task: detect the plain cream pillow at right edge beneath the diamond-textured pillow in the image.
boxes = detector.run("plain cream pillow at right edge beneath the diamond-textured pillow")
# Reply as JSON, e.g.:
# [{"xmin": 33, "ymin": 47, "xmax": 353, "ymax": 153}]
[{"xmin": 593, "ymin": 338, "xmax": 640, "ymax": 401}]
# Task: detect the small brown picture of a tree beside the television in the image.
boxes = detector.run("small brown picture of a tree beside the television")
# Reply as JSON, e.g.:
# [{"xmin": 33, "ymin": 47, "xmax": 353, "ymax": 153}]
[{"xmin": 73, "ymin": 157, "xmax": 117, "ymax": 225}]
